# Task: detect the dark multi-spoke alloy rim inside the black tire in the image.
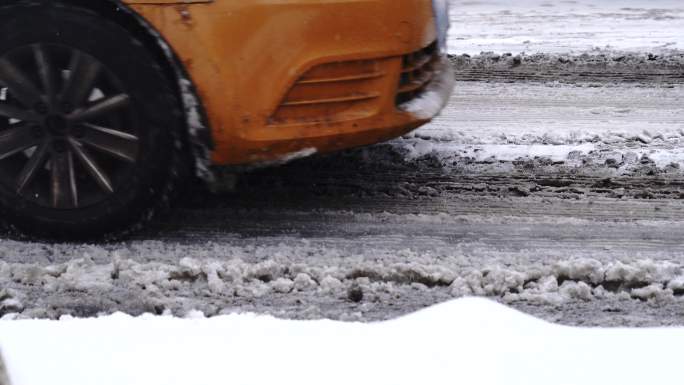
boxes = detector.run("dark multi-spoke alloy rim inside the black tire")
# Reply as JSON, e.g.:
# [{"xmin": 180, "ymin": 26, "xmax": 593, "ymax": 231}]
[{"xmin": 0, "ymin": 44, "xmax": 139, "ymax": 209}]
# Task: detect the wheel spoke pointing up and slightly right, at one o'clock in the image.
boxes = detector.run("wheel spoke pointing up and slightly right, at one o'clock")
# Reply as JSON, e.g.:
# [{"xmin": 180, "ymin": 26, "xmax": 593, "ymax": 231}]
[{"xmin": 61, "ymin": 51, "xmax": 100, "ymax": 106}]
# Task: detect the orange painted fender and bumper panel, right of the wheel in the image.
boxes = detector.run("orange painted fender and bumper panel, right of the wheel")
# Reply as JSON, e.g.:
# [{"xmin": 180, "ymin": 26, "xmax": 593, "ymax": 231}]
[{"xmin": 126, "ymin": 0, "xmax": 437, "ymax": 165}]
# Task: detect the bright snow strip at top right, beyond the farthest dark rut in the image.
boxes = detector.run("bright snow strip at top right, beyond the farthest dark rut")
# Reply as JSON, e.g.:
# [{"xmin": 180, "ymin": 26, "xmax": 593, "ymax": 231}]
[{"xmin": 449, "ymin": 0, "xmax": 684, "ymax": 55}]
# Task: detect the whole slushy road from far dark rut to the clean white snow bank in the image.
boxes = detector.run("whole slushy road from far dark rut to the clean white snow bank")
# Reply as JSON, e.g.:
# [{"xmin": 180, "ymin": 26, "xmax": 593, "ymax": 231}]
[{"xmin": 0, "ymin": 74, "xmax": 684, "ymax": 325}]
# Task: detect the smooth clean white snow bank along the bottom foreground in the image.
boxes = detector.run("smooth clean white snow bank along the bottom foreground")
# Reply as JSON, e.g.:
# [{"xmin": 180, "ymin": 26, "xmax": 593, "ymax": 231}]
[{"xmin": 0, "ymin": 299, "xmax": 684, "ymax": 385}]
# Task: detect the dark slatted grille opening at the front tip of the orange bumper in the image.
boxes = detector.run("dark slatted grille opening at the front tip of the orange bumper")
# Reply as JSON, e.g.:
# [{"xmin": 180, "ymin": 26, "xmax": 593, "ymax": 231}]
[{"xmin": 396, "ymin": 42, "xmax": 439, "ymax": 106}]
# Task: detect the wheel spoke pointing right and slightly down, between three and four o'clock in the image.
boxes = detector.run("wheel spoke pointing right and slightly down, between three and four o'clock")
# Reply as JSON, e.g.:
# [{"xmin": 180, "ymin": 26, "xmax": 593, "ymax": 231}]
[{"xmin": 79, "ymin": 123, "xmax": 138, "ymax": 163}]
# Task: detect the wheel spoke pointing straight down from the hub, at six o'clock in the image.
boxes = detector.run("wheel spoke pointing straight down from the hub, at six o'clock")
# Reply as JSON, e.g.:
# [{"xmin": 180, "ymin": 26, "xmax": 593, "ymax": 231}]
[{"xmin": 50, "ymin": 151, "xmax": 78, "ymax": 209}]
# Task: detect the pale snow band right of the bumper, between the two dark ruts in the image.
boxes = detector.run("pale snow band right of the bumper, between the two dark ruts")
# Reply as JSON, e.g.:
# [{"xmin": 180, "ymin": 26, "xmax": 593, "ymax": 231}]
[{"xmin": 394, "ymin": 82, "xmax": 684, "ymax": 170}]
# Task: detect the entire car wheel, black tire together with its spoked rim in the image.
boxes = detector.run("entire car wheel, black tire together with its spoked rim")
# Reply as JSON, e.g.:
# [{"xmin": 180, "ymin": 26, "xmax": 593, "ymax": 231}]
[{"xmin": 0, "ymin": 1, "xmax": 187, "ymax": 241}]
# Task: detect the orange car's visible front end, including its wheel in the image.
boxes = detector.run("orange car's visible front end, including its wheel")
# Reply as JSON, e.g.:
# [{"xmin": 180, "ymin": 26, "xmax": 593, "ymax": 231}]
[{"xmin": 0, "ymin": 0, "xmax": 453, "ymax": 239}]
